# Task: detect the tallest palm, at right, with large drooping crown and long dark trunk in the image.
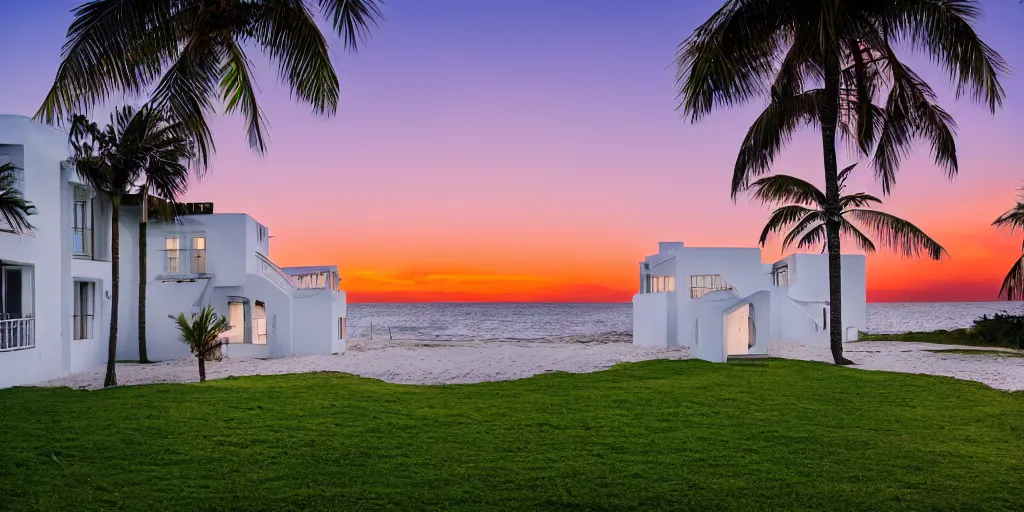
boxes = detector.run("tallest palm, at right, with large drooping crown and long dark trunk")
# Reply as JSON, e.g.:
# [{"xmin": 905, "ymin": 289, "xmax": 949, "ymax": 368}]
[{"xmin": 677, "ymin": 0, "xmax": 1007, "ymax": 364}]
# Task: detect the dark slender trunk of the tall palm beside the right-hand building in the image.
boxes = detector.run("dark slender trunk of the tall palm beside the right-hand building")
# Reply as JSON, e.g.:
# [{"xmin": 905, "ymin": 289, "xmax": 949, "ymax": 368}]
[{"xmin": 818, "ymin": 55, "xmax": 853, "ymax": 365}]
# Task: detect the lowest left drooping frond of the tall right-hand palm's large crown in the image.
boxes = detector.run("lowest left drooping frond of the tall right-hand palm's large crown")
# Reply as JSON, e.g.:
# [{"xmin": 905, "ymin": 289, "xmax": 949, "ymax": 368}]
[{"xmin": 732, "ymin": 89, "xmax": 821, "ymax": 194}]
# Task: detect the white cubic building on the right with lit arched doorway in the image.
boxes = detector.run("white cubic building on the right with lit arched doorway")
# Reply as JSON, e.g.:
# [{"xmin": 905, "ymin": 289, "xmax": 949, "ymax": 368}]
[{"xmin": 633, "ymin": 242, "xmax": 866, "ymax": 362}]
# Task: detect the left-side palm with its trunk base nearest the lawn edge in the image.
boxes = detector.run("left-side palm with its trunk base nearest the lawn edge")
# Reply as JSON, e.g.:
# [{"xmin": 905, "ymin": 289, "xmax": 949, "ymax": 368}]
[{"xmin": 69, "ymin": 106, "xmax": 189, "ymax": 387}]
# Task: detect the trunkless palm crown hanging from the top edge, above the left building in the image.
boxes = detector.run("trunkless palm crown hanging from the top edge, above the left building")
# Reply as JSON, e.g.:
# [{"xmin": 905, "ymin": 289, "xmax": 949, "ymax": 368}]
[{"xmin": 36, "ymin": 0, "xmax": 383, "ymax": 166}]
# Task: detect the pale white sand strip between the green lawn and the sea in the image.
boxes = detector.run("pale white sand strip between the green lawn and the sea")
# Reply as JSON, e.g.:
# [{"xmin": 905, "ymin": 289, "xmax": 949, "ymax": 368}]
[{"xmin": 34, "ymin": 339, "xmax": 1024, "ymax": 390}]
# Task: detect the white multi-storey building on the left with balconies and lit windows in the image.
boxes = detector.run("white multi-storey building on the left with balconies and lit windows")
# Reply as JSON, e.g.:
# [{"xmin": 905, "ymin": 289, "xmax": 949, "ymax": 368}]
[{"xmin": 0, "ymin": 116, "xmax": 346, "ymax": 388}]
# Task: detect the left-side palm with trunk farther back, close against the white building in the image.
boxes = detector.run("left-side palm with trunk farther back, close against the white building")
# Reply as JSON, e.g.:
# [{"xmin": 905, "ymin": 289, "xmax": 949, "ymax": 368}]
[{"xmin": 138, "ymin": 112, "xmax": 196, "ymax": 362}]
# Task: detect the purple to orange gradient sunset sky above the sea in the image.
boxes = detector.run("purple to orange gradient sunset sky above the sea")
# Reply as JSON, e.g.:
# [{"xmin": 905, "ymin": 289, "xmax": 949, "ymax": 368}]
[{"xmin": 0, "ymin": 0, "xmax": 1024, "ymax": 301}]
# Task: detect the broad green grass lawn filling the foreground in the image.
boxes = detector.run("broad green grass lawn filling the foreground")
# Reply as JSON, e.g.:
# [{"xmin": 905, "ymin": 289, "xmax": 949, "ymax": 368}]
[{"xmin": 0, "ymin": 359, "xmax": 1024, "ymax": 512}]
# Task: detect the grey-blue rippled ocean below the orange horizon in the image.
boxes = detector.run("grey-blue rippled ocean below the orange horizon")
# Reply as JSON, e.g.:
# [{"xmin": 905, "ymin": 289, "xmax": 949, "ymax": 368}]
[{"xmin": 348, "ymin": 302, "xmax": 1024, "ymax": 341}]
